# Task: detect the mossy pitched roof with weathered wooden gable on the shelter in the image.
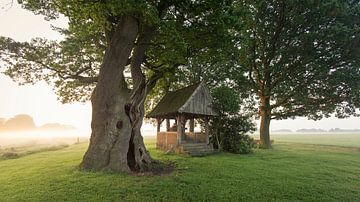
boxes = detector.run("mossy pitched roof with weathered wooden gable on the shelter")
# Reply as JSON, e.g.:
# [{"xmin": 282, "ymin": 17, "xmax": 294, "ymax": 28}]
[{"xmin": 147, "ymin": 83, "xmax": 216, "ymax": 118}]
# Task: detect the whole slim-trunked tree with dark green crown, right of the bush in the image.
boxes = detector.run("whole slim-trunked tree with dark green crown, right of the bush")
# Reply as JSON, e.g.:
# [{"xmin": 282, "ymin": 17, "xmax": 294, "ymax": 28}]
[{"xmin": 229, "ymin": 0, "xmax": 360, "ymax": 148}]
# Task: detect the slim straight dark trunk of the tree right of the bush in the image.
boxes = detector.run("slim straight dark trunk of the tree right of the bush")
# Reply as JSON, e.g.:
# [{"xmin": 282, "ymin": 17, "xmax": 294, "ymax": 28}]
[{"xmin": 260, "ymin": 97, "xmax": 271, "ymax": 149}]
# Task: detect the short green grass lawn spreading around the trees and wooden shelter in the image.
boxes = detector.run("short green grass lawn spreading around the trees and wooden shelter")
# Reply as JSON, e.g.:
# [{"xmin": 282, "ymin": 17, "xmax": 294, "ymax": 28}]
[{"xmin": 0, "ymin": 135, "xmax": 360, "ymax": 201}]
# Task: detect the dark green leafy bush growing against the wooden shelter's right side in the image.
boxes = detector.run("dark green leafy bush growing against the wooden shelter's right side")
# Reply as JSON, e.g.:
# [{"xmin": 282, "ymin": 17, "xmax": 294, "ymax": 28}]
[{"xmin": 210, "ymin": 86, "xmax": 255, "ymax": 154}]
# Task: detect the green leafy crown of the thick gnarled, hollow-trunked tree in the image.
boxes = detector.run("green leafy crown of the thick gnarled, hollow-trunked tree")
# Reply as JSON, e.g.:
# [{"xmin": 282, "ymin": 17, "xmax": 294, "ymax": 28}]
[{"xmin": 0, "ymin": 0, "xmax": 228, "ymax": 103}]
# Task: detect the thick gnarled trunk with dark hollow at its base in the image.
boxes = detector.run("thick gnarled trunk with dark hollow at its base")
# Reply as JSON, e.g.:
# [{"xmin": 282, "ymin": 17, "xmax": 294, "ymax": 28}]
[{"xmin": 81, "ymin": 16, "xmax": 152, "ymax": 172}]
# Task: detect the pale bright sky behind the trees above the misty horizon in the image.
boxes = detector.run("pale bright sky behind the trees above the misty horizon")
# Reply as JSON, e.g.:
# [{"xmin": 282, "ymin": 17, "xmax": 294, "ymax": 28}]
[{"xmin": 0, "ymin": 0, "xmax": 360, "ymax": 132}]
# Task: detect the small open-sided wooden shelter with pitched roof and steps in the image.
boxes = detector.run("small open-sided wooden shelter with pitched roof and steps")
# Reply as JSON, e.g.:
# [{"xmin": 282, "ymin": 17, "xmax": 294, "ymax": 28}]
[{"xmin": 147, "ymin": 83, "xmax": 216, "ymax": 154}]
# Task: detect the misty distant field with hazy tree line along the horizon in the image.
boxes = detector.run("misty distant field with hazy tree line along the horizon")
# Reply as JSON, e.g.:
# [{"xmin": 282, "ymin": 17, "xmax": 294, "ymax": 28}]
[{"xmin": 0, "ymin": 114, "xmax": 360, "ymax": 158}]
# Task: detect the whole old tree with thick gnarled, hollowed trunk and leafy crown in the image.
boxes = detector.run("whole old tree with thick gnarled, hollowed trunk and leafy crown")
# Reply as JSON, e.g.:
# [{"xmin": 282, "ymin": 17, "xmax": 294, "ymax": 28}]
[{"xmin": 0, "ymin": 0, "xmax": 229, "ymax": 172}]
